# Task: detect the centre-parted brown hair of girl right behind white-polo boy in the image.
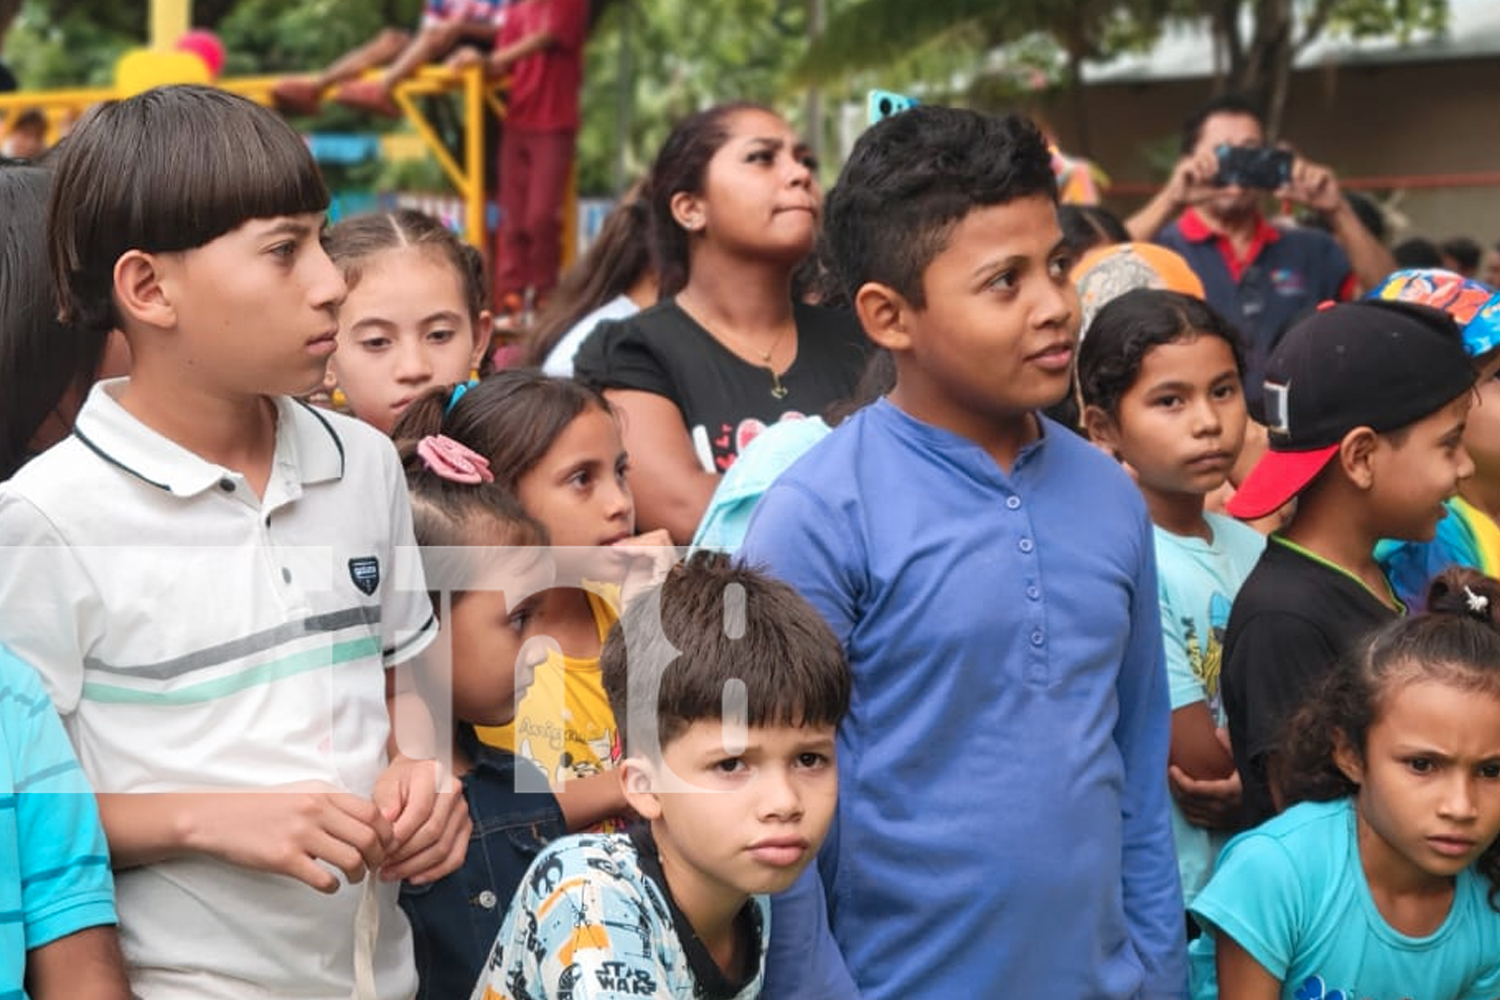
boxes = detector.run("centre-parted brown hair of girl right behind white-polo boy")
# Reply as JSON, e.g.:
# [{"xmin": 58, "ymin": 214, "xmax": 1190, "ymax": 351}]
[{"xmin": 323, "ymin": 208, "xmax": 489, "ymax": 328}]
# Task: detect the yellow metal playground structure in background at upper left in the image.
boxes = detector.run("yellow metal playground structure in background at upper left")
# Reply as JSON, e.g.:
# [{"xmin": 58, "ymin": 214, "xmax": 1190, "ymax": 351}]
[{"xmin": 0, "ymin": 0, "xmax": 522, "ymax": 250}]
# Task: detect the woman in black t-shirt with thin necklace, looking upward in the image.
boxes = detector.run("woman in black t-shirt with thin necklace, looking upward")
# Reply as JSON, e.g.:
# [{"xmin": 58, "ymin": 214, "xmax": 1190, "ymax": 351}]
[{"xmin": 575, "ymin": 103, "xmax": 869, "ymax": 544}]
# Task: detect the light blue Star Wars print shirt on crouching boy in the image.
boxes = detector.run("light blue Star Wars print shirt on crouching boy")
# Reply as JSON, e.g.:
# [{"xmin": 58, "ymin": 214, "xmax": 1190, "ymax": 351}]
[{"xmin": 471, "ymin": 825, "xmax": 771, "ymax": 1000}]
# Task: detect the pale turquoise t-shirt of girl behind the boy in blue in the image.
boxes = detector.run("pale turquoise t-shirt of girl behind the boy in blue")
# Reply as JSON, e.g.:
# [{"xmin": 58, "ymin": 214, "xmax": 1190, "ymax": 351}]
[{"xmin": 1155, "ymin": 514, "xmax": 1266, "ymax": 904}]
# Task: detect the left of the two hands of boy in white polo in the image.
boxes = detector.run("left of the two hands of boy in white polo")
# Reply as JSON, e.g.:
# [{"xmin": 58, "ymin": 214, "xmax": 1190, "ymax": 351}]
[{"xmin": 192, "ymin": 786, "xmax": 396, "ymax": 892}]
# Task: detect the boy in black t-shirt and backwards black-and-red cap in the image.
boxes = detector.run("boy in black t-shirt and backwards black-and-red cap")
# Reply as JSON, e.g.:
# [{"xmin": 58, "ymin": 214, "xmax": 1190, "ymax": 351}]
[{"xmin": 1221, "ymin": 300, "xmax": 1475, "ymax": 825}]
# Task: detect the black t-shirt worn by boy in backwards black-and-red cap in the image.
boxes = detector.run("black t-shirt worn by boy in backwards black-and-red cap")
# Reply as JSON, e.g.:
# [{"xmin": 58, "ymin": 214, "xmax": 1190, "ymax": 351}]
[{"xmin": 1220, "ymin": 537, "xmax": 1400, "ymax": 823}]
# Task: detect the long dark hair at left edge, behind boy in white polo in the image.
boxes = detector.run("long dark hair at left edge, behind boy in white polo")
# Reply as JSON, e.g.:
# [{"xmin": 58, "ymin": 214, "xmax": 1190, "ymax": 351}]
[{"xmin": 0, "ymin": 159, "xmax": 110, "ymax": 480}]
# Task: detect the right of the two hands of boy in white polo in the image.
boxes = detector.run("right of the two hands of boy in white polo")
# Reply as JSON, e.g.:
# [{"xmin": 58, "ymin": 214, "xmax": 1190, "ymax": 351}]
[{"xmin": 375, "ymin": 756, "xmax": 473, "ymax": 885}]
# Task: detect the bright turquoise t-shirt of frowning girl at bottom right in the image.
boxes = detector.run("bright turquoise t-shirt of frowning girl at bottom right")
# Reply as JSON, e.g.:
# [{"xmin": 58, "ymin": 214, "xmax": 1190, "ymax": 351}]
[{"xmin": 1188, "ymin": 799, "xmax": 1500, "ymax": 1000}]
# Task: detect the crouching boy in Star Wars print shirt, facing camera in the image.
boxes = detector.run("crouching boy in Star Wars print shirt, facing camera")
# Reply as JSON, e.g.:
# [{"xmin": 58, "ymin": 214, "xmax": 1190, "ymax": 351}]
[{"xmin": 474, "ymin": 552, "xmax": 849, "ymax": 1000}]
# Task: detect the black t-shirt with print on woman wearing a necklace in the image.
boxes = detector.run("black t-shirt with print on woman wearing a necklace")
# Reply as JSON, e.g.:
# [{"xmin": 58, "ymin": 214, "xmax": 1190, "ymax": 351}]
[{"xmin": 573, "ymin": 300, "xmax": 870, "ymax": 472}]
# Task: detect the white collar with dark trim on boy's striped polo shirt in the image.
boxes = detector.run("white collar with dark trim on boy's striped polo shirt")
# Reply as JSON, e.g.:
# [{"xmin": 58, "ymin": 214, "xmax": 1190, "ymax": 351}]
[{"xmin": 74, "ymin": 378, "xmax": 344, "ymax": 496}]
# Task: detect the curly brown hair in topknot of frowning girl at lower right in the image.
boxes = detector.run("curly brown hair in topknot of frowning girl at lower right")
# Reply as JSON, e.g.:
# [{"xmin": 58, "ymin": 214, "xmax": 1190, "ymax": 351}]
[{"xmin": 1278, "ymin": 567, "xmax": 1500, "ymax": 910}]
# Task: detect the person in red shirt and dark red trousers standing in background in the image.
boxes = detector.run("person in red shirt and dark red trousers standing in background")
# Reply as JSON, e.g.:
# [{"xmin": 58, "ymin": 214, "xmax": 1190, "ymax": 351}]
[{"xmin": 464, "ymin": 0, "xmax": 588, "ymax": 313}]
